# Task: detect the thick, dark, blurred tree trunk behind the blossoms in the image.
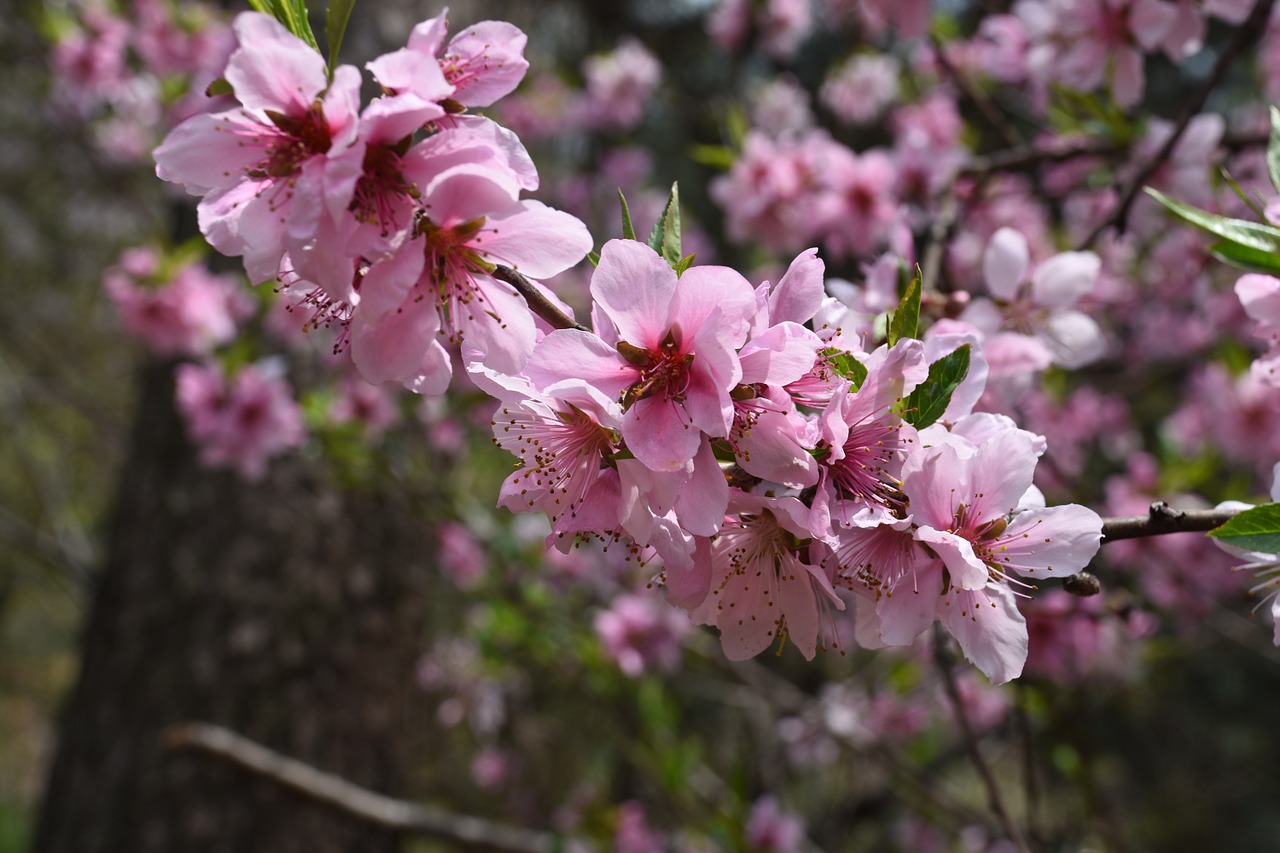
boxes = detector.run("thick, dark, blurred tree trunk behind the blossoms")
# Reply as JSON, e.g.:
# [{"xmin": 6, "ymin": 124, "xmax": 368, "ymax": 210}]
[{"xmin": 35, "ymin": 364, "xmax": 434, "ymax": 853}]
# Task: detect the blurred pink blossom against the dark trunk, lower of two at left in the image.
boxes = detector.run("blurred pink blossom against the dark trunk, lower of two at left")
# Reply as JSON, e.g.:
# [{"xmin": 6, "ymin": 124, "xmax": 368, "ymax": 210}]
[{"xmin": 178, "ymin": 362, "xmax": 306, "ymax": 480}]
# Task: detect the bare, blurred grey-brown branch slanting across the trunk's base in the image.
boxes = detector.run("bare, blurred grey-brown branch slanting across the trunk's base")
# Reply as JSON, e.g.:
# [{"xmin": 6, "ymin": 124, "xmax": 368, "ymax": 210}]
[{"xmin": 161, "ymin": 722, "xmax": 561, "ymax": 853}]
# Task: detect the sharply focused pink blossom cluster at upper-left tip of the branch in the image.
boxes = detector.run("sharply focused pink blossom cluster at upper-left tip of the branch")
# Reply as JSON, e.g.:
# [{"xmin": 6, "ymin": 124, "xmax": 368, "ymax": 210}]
[{"xmin": 155, "ymin": 13, "xmax": 591, "ymax": 393}]
